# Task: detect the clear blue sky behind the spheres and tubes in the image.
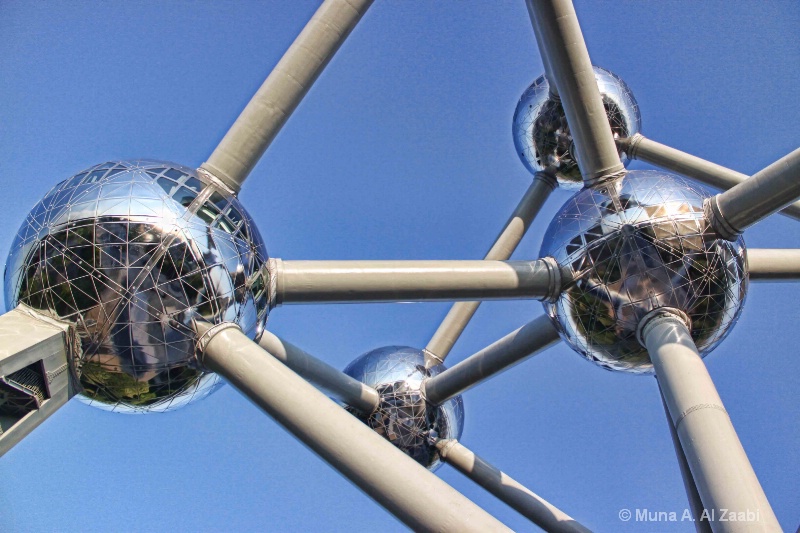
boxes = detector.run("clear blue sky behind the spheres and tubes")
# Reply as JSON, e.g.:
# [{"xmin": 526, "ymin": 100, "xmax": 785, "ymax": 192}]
[{"xmin": 0, "ymin": 0, "xmax": 800, "ymax": 531}]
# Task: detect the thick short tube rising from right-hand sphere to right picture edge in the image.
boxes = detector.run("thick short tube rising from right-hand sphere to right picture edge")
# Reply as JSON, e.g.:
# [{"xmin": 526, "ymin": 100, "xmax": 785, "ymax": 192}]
[{"xmin": 706, "ymin": 148, "xmax": 800, "ymax": 240}]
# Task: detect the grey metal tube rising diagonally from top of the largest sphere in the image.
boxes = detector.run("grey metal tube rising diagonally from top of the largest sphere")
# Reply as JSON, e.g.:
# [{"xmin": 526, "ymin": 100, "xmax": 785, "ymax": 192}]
[{"xmin": 200, "ymin": 0, "xmax": 372, "ymax": 192}]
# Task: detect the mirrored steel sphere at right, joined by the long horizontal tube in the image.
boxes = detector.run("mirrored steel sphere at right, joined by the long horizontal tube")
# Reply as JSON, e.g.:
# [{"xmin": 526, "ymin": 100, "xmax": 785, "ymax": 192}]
[{"xmin": 541, "ymin": 170, "xmax": 747, "ymax": 373}]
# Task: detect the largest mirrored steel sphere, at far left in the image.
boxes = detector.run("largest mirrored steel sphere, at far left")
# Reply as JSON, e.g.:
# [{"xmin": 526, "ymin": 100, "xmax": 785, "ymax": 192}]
[{"xmin": 5, "ymin": 160, "xmax": 268, "ymax": 413}]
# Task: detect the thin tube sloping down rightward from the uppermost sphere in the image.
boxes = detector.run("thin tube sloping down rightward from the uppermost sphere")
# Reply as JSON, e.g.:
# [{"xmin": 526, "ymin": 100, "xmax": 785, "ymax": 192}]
[{"xmin": 617, "ymin": 137, "xmax": 800, "ymax": 220}]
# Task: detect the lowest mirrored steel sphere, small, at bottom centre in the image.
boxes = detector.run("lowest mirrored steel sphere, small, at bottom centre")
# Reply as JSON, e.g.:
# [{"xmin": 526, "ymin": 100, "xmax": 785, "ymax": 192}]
[{"xmin": 344, "ymin": 346, "xmax": 464, "ymax": 470}]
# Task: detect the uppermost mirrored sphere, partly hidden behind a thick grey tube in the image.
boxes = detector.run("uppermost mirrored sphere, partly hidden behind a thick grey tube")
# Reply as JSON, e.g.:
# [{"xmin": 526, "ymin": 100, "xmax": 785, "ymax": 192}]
[{"xmin": 513, "ymin": 67, "xmax": 642, "ymax": 190}]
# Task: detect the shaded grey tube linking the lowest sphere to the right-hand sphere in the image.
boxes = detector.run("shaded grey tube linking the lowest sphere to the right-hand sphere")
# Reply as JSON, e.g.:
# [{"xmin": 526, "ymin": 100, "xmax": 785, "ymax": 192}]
[{"xmin": 425, "ymin": 315, "xmax": 560, "ymax": 405}]
